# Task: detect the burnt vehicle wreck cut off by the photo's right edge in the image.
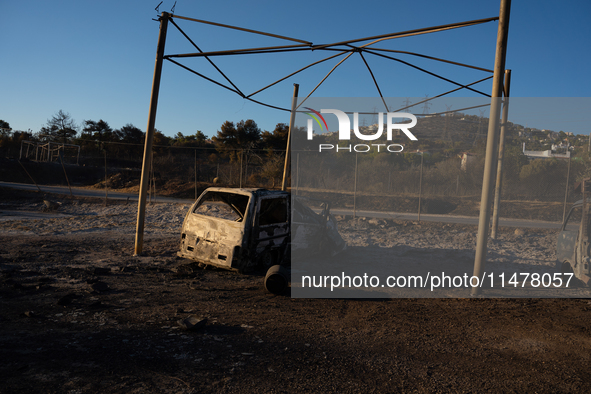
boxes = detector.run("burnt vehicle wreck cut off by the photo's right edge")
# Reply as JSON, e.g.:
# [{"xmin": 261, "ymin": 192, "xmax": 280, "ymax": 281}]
[{"xmin": 556, "ymin": 179, "xmax": 591, "ymax": 286}]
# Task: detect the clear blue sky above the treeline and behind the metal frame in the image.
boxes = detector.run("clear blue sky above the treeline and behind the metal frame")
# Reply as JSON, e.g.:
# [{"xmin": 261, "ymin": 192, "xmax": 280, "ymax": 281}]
[{"xmin": 0, "ymin": 0, "xmax": 591, "ymax": 136}]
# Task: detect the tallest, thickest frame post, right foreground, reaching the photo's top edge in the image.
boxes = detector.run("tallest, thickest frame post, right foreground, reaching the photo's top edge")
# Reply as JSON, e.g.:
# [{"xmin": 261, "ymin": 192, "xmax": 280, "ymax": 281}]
[{"xmin": 471, "ymin": 0, "xmax": 511, "ymax": 296}]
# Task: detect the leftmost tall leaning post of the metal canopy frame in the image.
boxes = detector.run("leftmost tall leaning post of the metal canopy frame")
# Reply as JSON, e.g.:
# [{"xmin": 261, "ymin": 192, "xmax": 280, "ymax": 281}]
[{"xmin": 135, "ymin": 12, "xmax": 170, "ymax": 255}]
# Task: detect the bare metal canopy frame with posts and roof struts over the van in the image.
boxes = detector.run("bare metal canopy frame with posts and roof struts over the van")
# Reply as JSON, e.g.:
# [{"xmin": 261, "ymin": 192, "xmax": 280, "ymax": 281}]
[{"xmin": 135, "ymin": 0, "xmax": 511, "ymax": 295}]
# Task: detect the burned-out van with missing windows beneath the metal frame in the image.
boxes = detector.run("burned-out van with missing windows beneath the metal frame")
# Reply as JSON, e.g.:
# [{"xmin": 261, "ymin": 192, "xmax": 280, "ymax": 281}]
[{"xmin": 177, "ymin": 187, "xmax": 346, "ymax": 288}]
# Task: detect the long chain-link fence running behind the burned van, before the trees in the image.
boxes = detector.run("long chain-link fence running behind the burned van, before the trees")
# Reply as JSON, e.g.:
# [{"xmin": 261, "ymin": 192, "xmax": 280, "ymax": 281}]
[{"xmin": 2, "ymin": 139, "xmax": 588, "ymax": 225}]
